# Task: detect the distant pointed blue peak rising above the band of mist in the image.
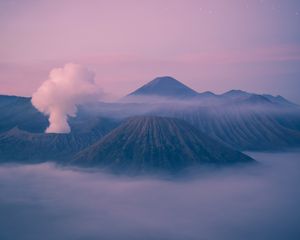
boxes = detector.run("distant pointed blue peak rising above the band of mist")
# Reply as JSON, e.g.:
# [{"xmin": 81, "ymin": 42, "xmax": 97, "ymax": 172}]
[{"xmin": 128, "ymin": 76, "xmax": 198, "ymax": 99}]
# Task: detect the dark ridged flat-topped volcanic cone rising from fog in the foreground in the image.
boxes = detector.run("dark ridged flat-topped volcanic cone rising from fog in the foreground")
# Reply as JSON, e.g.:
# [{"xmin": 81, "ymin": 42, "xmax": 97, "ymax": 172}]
[{"xmin": 72, "ymin": 116, "xmax": 253, "ymax": 173}]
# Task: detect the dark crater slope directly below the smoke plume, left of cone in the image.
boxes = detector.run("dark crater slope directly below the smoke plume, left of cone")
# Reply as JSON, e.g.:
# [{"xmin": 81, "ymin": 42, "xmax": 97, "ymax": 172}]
[{"xmin": 0, "ymin": 119, "xmax": 117, "ymax": 162}]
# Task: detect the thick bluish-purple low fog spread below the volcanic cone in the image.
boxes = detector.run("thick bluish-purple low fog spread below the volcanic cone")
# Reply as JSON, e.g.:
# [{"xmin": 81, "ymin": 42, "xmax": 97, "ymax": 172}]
[{"xmin": 0, "ymin": 152, "xmax": 300, "ymax": 240}]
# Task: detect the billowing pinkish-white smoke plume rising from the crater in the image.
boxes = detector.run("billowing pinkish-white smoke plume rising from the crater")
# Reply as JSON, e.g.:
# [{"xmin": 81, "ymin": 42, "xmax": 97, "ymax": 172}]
[{"xmin": 31, "ymin": 63, "xmax": 98, "ymax": 133}]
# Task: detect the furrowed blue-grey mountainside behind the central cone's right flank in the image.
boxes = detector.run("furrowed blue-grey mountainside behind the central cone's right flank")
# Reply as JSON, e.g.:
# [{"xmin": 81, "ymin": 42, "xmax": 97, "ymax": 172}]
[{"xmin": 152, "ymin": 104, "xmax": 300, "ymax": 150}]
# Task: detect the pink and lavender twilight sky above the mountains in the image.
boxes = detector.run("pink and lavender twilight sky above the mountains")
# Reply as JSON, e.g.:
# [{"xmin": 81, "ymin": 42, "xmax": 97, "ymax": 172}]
[{"xmin": 0, "ymin": 0, "xmax": 300, "ymax": 103}]
